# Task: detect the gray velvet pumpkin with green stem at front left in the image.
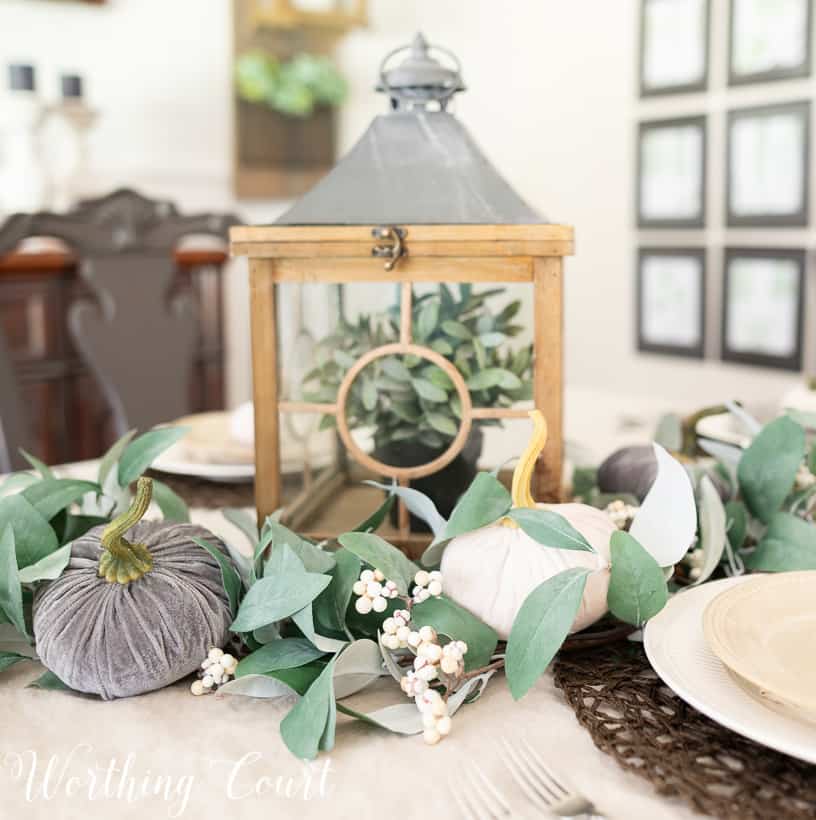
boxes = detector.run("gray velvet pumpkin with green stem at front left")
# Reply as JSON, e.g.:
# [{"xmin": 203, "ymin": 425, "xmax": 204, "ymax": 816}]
[{"xmin": 34, "ymin": 479, "xmax": 232, "ymax": 700}]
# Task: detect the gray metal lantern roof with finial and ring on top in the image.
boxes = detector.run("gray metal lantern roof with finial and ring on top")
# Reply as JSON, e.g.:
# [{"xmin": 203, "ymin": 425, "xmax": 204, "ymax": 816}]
[{"xmin": 277, "ymin": 34, "xmax": 545, "ymax": 225}]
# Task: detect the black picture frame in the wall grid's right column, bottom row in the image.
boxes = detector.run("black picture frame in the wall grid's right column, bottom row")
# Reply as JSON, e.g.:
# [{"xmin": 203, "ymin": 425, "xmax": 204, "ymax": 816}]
[{"xmin": 720, "ymin": 247, "xmax": 806, "ymax": 371}]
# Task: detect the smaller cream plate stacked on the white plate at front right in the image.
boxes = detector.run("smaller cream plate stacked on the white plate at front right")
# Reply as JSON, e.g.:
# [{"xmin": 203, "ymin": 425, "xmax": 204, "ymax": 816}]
[{"xmin": 703, "ymin": 572, "xmax": 816, "ymax": 722}]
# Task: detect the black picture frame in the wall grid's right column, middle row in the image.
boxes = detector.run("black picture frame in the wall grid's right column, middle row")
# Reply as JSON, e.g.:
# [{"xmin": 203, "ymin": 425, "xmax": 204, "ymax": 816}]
[{"xmin": 725, "ymin": 100, "xmax": 810, "ymax": 228}]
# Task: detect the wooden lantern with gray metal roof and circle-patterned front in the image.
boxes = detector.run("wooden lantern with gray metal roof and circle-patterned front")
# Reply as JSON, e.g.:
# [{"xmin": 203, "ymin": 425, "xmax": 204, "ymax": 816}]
[{"xmin": 231, "ymin": 33, "xmax": 573, "ymax": 552}]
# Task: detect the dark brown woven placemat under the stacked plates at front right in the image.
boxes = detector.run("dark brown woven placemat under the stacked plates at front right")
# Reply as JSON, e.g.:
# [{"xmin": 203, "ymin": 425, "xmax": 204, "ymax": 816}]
[{"xmin": 554, "ymin": 642, "xmax": 816, "ymax": 820}]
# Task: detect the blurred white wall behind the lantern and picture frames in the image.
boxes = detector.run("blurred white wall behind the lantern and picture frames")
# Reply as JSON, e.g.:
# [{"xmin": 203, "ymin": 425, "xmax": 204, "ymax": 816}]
[{"xmin": 0, "ymin": 0, "xmax": 812, "ymax": 422}]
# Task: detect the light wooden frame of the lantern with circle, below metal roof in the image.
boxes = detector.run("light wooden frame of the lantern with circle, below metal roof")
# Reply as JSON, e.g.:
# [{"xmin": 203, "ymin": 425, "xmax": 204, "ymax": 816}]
[{"xmin": 231, "ymin": 224, "xmax": 573, "ymax": 545}]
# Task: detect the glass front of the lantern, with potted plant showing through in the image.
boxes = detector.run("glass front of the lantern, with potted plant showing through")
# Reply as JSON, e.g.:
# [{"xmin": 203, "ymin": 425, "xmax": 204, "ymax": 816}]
[{"xmin": 279, "ymin": 282, "xmax": 533, "ymax": 536}]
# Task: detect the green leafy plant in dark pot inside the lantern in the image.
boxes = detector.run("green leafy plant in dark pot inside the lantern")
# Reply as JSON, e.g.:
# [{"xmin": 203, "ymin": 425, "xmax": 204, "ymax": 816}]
[{"xmin": 303, "ymin": 284, "xmax": 532, "ymax": 515}]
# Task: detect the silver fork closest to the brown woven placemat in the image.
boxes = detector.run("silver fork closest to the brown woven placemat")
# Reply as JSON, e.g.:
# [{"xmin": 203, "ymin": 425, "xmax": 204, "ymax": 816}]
[{"xmin": 502, "ymin": 739, "xmax": 606, "ymax": 820}]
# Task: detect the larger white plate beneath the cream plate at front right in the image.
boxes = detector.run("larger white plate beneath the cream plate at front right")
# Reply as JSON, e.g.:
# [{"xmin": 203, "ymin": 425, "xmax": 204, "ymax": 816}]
[{"xmin": 643, "ymin": 577, "xmax": 816, "ymax": 763}]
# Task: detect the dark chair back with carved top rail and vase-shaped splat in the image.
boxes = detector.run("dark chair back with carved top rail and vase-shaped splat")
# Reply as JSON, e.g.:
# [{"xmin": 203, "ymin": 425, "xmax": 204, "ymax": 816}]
[{"xmin": 0, "ymin": 189, "xmax": 239, "ymax": 436}]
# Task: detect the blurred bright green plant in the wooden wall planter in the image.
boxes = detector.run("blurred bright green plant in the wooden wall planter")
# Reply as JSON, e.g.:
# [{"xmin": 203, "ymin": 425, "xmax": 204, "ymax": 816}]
[{"xmin": 235, "ymin": 51, "xmax": 347, "ymax": 117}]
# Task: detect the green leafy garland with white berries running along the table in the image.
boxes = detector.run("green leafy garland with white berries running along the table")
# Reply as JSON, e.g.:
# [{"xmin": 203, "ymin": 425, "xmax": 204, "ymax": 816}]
[{"xmin": 0, "ymin": 405, "xmax": 816, "ymax": 759}]
